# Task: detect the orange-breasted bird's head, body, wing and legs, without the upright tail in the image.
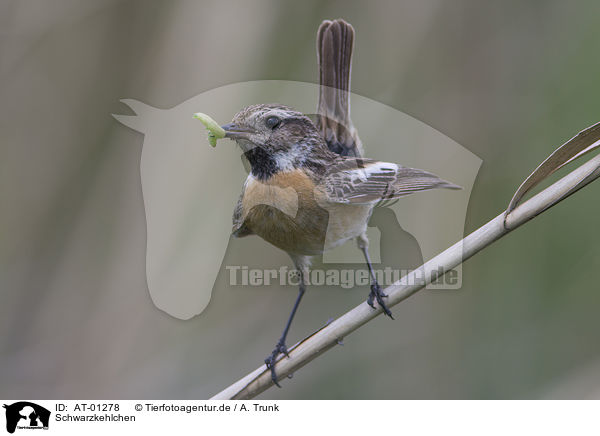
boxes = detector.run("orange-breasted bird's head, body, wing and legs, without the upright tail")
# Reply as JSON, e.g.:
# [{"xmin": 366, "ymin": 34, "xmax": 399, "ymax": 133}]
[{"xmin": 222, "ymin": 104, "xmax": 460, "ymax": 386}]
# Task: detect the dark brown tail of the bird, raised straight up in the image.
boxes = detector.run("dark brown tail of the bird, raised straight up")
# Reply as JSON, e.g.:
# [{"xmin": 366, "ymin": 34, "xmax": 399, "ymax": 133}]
[{"xmin": 317, "ymin": 19, "xmax": 363, "ymax": 157}]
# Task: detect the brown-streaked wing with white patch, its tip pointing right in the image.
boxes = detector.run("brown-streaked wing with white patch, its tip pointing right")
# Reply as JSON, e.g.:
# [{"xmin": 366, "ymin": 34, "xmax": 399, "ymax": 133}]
[{"xmin": 318, "ymin": 158, "xmax": 461, "ymax": 204}]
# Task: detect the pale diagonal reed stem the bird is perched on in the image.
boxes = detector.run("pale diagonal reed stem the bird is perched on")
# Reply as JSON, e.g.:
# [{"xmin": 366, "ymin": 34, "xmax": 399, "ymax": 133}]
[{"xmin": 212, "ymin": 148, "xmax": 600, "ymax": 400}]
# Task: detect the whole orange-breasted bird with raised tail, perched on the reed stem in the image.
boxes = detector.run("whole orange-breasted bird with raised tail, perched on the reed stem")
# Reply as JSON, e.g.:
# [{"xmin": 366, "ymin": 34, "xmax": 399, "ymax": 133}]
[{"xmin": 221, "ymin": 19, "xmax": 460, "ymax": 387}]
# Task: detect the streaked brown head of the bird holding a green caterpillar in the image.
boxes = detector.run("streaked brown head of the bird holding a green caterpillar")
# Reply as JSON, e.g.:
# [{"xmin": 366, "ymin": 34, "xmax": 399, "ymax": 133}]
[{"xmin": 222, "ymin": 104, "xmax": 326, "ymax": 179}]
